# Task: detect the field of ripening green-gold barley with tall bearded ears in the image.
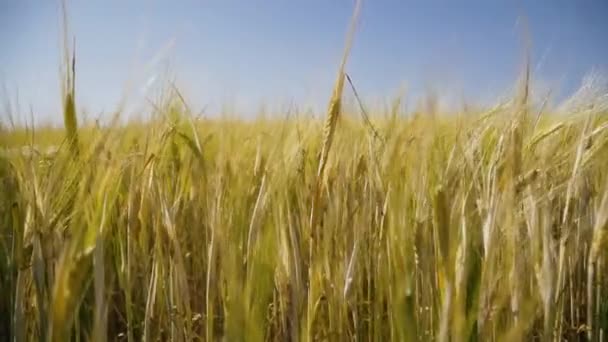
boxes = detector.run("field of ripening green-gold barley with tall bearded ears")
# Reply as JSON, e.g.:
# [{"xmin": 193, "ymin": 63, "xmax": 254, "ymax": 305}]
[{"xmin": 0, "ymin": 1, "xmax": 608, "ymax": 341}]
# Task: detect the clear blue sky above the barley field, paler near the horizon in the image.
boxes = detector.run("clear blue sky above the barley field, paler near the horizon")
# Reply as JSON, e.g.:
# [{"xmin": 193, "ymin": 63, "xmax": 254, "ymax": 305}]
[{"xmin": 0, "ymin": 0, "xmax": 608, "ymax": 121}]
